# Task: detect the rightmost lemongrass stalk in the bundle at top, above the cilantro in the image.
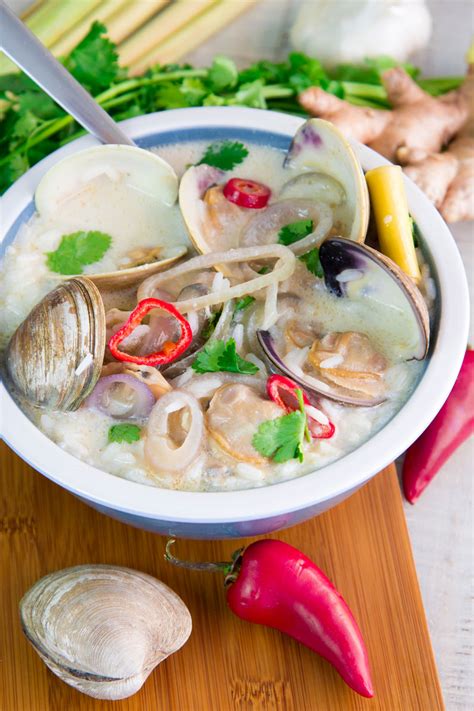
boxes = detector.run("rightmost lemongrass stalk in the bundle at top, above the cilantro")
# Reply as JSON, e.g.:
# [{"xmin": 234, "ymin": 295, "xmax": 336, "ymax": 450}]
[{"xmin": 130, "ymin": 0, "xmax": 257, "ymax": 75}]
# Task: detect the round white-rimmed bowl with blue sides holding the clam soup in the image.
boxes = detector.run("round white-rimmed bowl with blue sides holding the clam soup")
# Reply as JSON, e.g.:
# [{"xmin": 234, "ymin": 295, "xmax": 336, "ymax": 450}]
[{"xmin": 0, "ymin": 108, "xmax": 469, "ymax": 538}]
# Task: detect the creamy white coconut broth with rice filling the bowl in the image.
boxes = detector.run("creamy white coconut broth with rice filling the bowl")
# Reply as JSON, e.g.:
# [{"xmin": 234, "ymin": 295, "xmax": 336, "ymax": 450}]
[{"xmin": 0, "ymin": 141, "xmax": 424, "ymax": 490}]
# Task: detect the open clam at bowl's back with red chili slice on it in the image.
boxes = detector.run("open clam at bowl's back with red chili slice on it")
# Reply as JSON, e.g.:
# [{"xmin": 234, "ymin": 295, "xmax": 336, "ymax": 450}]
[{"xmin": 179, "ymin": 119, "xmax": 369, "ymax": 279}]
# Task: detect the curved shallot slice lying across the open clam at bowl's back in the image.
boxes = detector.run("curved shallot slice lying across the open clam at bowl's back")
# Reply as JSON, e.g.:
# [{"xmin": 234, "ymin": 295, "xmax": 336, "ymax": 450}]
[{"xmin": 240, "ymin": 200, "xmax": 333, "ymax": 255}]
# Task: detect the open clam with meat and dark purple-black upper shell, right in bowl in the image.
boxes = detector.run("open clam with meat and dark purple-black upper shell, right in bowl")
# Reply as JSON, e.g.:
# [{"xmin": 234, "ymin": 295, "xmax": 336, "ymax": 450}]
[{"xmin": 257, "ymin": 238, "xmax": 430, "ymax": 407}]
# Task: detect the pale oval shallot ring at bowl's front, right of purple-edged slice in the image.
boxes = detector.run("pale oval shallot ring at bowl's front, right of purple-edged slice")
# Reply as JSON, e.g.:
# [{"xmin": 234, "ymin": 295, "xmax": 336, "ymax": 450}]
[{"xmin": 145, "ymin": 390, "xmax": 204, "ymax": 474}]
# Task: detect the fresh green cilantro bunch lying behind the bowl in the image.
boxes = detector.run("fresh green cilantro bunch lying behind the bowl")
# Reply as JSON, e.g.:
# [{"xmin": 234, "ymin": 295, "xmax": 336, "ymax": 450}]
[{"xmin": 0, "ymin": 22, "xmax": 462, "ymax": 192}]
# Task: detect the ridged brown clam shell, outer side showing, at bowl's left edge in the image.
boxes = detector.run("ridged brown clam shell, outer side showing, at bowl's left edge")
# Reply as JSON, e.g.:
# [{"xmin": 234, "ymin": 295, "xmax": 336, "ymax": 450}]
[{"xmin": 5, "ymin": 277, "xmax": 106, "ymax": 410}]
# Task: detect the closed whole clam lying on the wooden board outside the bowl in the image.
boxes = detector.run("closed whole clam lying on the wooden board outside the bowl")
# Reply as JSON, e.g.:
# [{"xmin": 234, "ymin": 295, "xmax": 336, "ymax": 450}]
[{"xmin": 20, "ymin": 565, "xmax": 192, "ymax": 700}]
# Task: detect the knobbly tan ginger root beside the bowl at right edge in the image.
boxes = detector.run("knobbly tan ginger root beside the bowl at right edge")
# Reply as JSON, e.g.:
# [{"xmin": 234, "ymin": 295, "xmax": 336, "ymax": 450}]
[{"xmin": 299, "ymin": 64, "xmax": 474, "ymax": 222}]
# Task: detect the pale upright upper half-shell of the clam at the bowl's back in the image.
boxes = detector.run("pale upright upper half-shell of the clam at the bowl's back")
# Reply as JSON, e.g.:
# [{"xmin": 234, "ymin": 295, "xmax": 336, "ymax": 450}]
[{"xmin": 282, "ymin": 119, "xmax": 369, "ymax": 242}]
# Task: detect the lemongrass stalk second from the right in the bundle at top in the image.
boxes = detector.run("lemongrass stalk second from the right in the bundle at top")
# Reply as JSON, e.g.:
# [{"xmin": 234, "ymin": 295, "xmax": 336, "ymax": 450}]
[{"xmin": 119, "ymin": 0, "xmax": 217, "ymax": 67}]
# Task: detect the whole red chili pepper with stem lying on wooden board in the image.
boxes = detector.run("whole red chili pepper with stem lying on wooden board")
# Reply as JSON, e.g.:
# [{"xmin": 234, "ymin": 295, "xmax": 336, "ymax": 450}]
[{"xmin": 165, "ymin": 539, "xmax": 374, "ymax": 697}]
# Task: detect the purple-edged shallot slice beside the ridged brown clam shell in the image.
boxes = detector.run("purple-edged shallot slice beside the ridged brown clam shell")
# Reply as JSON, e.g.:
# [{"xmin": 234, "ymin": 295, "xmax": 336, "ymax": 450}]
[{"xmin": 84, "ymin": 373, "xmax": 155, "ymax": 420}]
